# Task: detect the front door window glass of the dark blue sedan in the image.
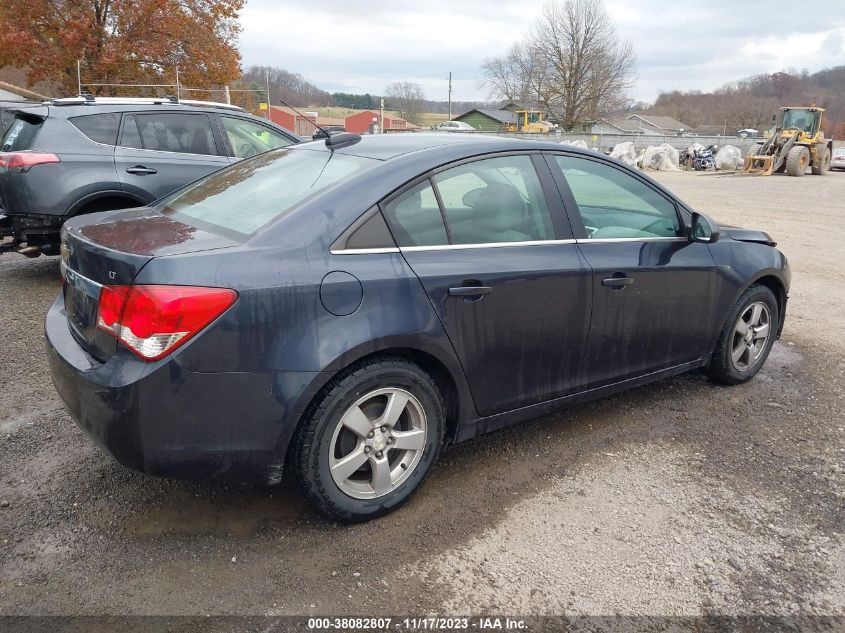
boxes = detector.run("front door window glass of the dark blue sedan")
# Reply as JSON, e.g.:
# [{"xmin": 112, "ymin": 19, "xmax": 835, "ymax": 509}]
[{"xmin": 555, "ymin": 156, "xmax": 682, "ymax": 240}]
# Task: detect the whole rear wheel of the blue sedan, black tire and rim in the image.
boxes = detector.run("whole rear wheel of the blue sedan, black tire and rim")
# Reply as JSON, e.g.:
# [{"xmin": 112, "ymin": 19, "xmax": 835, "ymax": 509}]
[{"xmin": 292, "ymin": 357, "xmax": 445, "ymax": 523}]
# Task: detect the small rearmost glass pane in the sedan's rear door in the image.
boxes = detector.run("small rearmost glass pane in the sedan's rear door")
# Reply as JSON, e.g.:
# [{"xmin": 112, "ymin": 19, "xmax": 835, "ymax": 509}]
[{"xmin": 384, "ymin": 180, "xmax": 449, "ymax": 246}]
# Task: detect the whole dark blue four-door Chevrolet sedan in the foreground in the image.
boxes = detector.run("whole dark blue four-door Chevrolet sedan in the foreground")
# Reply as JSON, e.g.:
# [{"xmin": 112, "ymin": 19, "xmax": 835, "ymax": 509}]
[{"xmin": 46, "ymin": 134, "xmax": 790, "ymax": 521}]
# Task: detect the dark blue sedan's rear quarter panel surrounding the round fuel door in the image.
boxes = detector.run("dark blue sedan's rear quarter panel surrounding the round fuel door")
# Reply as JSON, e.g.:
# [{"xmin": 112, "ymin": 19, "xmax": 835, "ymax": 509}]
[{"xmin": 135, "ymin": 247, "xmax": 468, "ymax": 372}]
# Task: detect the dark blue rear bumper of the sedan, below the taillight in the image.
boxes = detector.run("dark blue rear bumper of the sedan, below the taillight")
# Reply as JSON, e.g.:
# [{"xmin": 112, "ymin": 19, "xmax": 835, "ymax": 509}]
[{"xmin": 45, "ymin": 295, "xmax": 320, "ymax": 484}]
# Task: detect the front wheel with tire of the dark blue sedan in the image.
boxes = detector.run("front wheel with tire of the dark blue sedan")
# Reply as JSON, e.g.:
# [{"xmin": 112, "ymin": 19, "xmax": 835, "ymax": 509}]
[{"xmin": 707, "ymin": 284, "xmax": 780, "ymax": 385}]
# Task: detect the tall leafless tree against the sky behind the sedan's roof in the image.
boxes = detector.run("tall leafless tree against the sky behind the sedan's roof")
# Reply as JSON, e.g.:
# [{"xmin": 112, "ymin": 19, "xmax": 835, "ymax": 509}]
[{"xmin": 482, "ymin": 0, "xmax": 636, "ymax": 130}]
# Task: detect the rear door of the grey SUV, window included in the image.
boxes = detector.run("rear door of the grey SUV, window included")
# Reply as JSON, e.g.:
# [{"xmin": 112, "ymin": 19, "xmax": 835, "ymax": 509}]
[{"xmin": 114, "ymin": 112, "xmax": 229, "ymax": 202}]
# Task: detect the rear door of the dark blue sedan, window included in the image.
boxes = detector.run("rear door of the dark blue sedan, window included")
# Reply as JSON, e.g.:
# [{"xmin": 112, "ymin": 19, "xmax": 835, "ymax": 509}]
[{"xmin": 382, "ymin": 154, "xmax": 591, "ymax": 416}]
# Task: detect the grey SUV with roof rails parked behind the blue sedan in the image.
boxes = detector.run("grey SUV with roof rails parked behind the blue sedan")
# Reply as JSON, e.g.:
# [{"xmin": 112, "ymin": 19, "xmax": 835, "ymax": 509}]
[{"xmin": 0, "ymin": 96, "xmax": 300, "ymax": 257}]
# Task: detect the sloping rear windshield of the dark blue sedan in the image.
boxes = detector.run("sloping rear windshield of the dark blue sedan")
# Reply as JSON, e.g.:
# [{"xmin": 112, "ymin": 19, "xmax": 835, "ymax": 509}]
[{"xmin": 156, "ymin": 149, "xmax": 376, "ymax": 237}]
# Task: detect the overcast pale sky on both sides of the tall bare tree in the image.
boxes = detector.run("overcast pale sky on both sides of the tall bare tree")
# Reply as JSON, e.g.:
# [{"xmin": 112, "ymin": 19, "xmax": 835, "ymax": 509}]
[{"xmin": 240, "ymin": 0, "xmax": 845, "ymax": 101}]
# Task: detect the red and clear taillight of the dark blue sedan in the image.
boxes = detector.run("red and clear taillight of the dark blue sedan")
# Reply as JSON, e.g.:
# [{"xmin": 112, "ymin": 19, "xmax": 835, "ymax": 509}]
[{"xmin": 97, "ymin": 286, "xmax": 238, "ymax": 361}]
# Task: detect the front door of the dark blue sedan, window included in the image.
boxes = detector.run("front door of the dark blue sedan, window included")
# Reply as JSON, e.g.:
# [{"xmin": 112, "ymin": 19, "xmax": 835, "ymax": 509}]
[{"xmin": 547, "ymin": 154, "xmax": 716, "ymax": 387}]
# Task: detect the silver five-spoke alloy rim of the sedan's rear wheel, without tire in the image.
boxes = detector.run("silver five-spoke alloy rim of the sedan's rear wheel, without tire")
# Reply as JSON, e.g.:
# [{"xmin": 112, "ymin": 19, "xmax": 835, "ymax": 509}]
[{"xmin": 329, "ymin": 387, "xmax": 427, "ymax": 499}]
